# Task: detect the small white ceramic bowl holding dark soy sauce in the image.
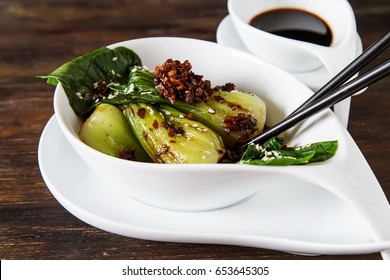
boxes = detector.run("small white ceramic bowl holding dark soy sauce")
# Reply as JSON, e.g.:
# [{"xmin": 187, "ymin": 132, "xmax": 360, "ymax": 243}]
[{"xmin": 227, "ymin": 0, "xmax": 358, "ymax": 74}]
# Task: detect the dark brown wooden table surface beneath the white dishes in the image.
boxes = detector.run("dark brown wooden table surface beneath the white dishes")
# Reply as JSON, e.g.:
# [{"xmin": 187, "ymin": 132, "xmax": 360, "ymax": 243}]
[{"xmin": 0, "ymin": 0, "xmax": 390, "ymax": 259}]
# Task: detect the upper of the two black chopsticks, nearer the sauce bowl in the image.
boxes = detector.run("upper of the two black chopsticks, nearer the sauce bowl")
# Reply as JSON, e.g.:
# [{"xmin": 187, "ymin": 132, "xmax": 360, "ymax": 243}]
[{"xmin": 291, "ymin": 32, "xmax": 390, "ymax": 115}]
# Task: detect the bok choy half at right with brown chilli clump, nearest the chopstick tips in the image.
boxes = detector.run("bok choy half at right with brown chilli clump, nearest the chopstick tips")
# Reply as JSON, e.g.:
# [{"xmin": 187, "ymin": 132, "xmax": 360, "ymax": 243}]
[{"xmin": 109, "ymin": 66, "xmax": 266, "ymax": 148}]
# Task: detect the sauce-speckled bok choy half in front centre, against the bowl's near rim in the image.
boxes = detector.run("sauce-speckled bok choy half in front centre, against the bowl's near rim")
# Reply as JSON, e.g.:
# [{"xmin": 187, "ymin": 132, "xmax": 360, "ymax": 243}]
[{"xmin": 124, "ymin": 103, "xmax": 225, "ymax": 163}]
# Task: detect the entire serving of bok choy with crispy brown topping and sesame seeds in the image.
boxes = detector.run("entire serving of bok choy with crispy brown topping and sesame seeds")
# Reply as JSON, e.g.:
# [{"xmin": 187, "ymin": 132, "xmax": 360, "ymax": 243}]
[{"xmin": 38, "ymin": 47, "xmax": 337, "ymax": 165}]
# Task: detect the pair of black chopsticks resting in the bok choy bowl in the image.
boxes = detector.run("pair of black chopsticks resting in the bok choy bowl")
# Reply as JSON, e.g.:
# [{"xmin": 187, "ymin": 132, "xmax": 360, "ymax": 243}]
[{"xmin": 242, "ymin": 32, "xmax": 390, "ymax": 148}]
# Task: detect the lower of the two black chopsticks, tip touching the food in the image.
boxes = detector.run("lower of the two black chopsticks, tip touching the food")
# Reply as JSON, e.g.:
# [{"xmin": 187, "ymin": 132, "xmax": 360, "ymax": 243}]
[{"xmin": 242, "ymin": 59, "xmax": 390, "ymax": 148}]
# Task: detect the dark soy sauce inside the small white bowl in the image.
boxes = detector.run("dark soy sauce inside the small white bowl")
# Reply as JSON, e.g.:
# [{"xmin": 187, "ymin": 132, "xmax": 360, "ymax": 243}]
[{"xmin": 249, "ymin": 8, "xmax": 337, "ymax": 47}]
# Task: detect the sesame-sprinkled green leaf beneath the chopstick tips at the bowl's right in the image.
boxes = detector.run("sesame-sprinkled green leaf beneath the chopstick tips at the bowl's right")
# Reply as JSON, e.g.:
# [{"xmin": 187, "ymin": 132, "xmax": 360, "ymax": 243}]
[{"xmin": 238, "ymin": 137, "xmax": 338, "ymax": 165}]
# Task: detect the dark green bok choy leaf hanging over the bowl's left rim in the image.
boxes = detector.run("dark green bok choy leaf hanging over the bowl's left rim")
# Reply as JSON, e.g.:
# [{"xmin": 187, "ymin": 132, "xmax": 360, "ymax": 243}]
[{"xmin": 38, "ymin": 47, "xmax": 141, "ymax": 118}]
